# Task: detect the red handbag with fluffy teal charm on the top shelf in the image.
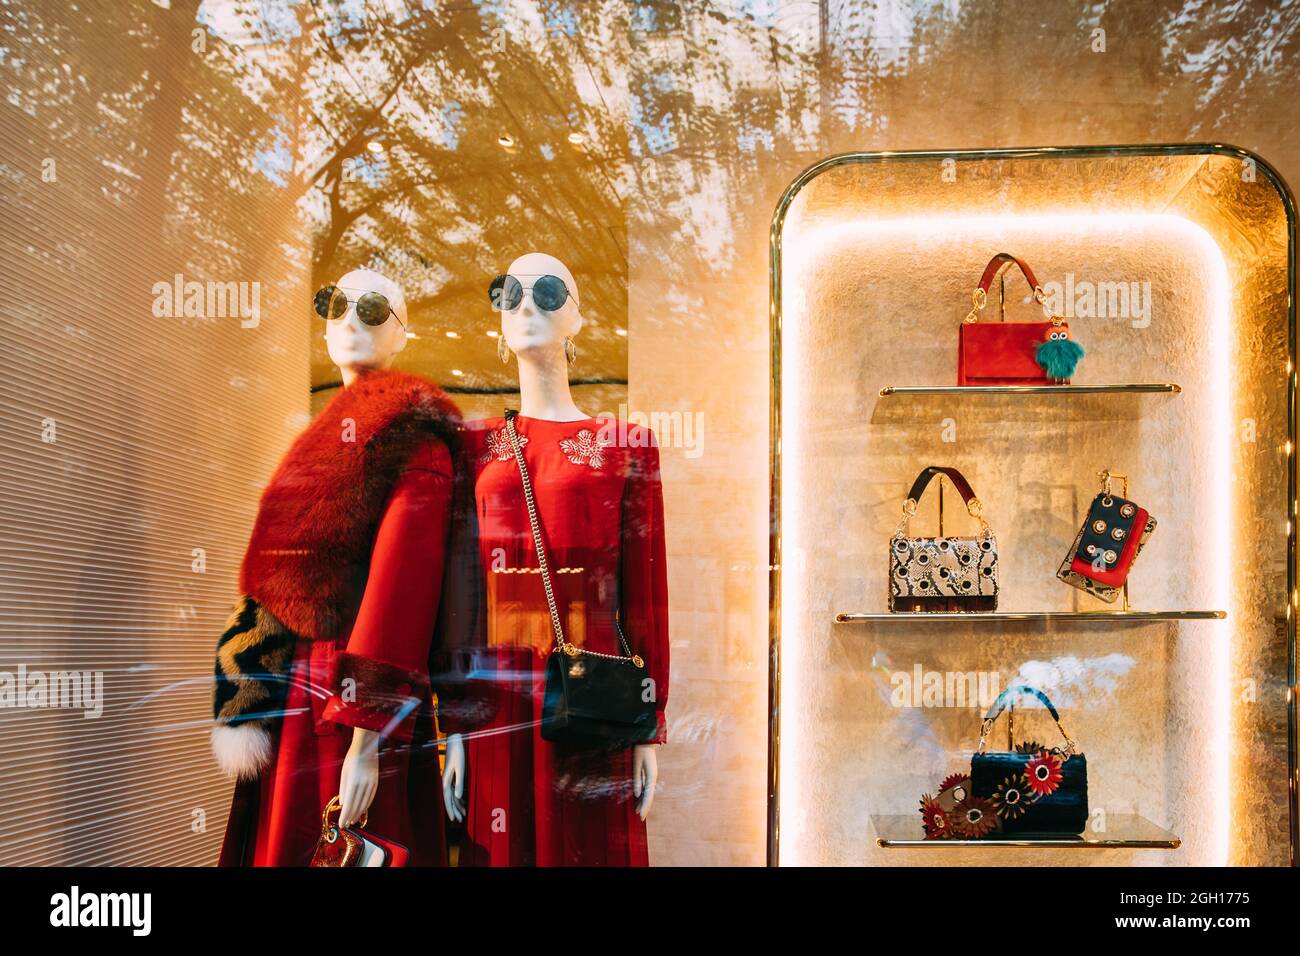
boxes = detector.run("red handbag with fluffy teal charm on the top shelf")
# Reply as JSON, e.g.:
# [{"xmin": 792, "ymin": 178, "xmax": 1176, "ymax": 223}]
[{"xmin": 957, "ymin": 252, "xmax": 1083, "ymax": 386}]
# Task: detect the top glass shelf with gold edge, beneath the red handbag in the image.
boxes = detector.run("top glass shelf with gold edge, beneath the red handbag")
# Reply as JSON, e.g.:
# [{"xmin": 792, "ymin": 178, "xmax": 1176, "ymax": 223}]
[{"xmin": 871, "ymin": 382, "xmax": 1183, "ymax": 424}]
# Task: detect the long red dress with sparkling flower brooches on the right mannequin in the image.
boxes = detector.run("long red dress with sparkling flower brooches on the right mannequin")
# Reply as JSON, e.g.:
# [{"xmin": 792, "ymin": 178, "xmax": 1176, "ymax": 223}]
[{"xmin": 462, "ymin": 416, "xmax": 668, "ymax": 866}]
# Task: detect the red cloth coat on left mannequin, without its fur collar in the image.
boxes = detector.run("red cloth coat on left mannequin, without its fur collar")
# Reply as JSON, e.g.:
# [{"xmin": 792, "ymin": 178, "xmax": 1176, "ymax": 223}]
[{"xmin": 221, "ymin": 437, "xmax": 452, "ymax": 866}]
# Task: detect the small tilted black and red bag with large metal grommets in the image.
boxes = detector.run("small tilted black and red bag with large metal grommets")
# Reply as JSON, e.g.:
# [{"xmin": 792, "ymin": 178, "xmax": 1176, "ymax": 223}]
[{"xmin": 1057, "ymin": 471, "xmax": 1156, "ymax": 604}]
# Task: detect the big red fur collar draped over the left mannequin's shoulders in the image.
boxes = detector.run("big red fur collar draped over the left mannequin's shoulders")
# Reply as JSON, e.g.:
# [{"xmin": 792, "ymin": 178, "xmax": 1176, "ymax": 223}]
[{"xmin": 239, "ymin": 372, "xmax": 460, "ymax": 639}]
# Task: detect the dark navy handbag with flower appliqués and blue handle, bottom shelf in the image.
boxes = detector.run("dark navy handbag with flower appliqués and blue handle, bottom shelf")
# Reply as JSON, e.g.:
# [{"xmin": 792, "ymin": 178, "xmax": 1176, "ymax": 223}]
[{"xmin": 970, "ymin": 684, "xmax": 1088, "ymax": 836}]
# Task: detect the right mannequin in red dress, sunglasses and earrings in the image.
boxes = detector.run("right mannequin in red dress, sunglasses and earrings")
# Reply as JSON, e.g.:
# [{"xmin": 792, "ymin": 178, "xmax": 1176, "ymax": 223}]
[{"xmin": 445, "ymin": 252, "xmax": 668, "ymax": 866}]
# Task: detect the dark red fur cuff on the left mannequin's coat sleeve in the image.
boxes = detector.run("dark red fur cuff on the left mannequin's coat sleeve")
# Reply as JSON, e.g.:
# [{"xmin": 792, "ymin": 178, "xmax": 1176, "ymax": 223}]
[{"xmin": 324, "ymin": 650, "xmax": 429, "ymax": 741}]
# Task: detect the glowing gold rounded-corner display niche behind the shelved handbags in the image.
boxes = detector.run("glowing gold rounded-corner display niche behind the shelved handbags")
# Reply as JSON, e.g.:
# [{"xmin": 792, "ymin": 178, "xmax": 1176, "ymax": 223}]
[{"xmin": 768, "ymin": 146, "xmax": 1296, "ymax": 865}]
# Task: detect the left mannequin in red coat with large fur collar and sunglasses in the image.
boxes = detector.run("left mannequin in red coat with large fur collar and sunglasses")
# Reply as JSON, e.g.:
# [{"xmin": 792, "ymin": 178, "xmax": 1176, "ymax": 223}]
[{"xmin": 212, "ymin": 269, "xmax": 473, "ymax": 865}]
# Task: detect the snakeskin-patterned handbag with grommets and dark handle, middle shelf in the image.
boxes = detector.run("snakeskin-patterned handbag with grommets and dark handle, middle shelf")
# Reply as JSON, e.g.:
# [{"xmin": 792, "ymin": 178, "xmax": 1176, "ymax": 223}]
[{"xmin": 889, "ymin": 464, "xmax": 997, "ymax": 614}]
